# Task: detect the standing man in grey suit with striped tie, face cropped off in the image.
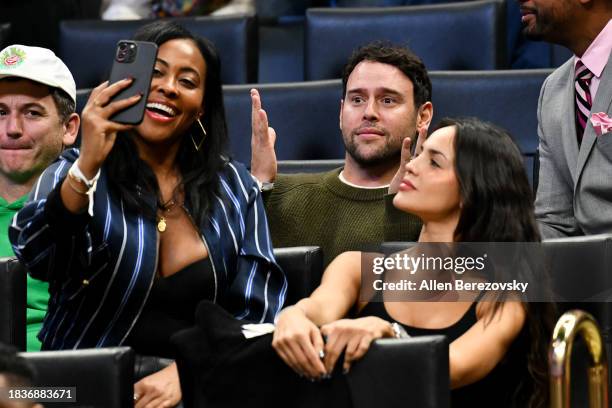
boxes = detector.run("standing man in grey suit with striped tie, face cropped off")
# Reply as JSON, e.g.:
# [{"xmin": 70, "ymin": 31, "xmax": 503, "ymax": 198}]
[{"xmin": 518, "ymin": 0, "xmax": 612, "ymax": 238}]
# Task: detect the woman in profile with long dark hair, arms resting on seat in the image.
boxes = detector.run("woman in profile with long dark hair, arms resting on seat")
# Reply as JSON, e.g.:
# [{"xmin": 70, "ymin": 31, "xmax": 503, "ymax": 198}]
[{"xmin": 272, "ymin": 119, "xmax": 553, "ymax": 407}]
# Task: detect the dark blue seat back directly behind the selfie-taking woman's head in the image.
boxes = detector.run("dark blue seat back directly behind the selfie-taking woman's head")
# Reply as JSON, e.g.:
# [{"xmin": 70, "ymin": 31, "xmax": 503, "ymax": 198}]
[{"xmin": 59, "ymin": 15, "xmax": 258, "ymax": 89}]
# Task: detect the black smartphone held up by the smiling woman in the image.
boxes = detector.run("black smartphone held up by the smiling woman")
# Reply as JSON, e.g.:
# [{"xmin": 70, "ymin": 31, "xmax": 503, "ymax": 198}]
[{"xmin": 110, "ymin": 40, "xmax": 157, "ymax": 125}]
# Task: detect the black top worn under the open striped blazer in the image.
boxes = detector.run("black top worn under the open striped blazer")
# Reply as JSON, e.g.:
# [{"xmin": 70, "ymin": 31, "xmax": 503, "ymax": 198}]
[{"xmin": 124, "ymin": 257, "xmax": 215, "ymax": 358}]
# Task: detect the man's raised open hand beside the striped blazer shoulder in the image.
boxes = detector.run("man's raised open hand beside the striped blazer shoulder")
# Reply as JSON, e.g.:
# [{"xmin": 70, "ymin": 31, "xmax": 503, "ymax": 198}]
[{"xmin": 251, "ymin": 89, "xmax": 277, "ymax": 182}]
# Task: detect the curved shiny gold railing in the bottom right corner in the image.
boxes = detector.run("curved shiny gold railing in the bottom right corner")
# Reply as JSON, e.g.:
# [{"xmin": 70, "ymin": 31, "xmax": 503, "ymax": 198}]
[{"xmin": 548, "ymin": 310, "xmax": 608, "ymax": 408}]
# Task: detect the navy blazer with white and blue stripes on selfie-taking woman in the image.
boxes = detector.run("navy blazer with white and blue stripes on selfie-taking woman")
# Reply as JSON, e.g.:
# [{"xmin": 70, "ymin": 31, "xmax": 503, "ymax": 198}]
[{"xmin": 9, "ymin": 149, "xmax": 287, "ymax": 349}]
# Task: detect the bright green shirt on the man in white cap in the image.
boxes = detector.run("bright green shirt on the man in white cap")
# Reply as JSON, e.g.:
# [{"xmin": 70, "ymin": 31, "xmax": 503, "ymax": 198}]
[{"xmin": 0, "ymin": 194, "xmax": 49, "ymax": 351}]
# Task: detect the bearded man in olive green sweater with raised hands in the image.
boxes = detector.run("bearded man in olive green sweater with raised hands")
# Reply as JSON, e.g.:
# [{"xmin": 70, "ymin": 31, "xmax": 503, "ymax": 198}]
[{"xmin": 251, "ymin": 44, "xmax": 433, "ymax": 265}]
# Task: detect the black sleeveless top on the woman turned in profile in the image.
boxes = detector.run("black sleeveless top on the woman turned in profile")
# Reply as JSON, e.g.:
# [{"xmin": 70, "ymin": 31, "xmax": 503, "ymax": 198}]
[{"xmin": 358, "ymin": 301, "xmax": 529, "ymax": 408}]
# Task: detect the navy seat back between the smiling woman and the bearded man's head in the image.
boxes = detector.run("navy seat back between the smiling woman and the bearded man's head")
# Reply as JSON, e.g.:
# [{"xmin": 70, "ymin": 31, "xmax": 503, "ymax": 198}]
[{"xmin": 223, "ymin": 80, "xmax": 344, "ymax": 163}]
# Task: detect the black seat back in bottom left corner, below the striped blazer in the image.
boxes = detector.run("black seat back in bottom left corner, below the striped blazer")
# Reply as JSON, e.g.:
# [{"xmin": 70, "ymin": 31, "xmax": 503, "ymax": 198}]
[{"xmin": 21, "ymin": 347, "xmax": 134, "ymax": 408}]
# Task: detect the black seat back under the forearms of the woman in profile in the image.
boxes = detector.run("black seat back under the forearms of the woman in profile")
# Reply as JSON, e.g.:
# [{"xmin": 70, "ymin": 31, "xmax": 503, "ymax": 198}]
[{"xmin": 347, "ymin": 336, "xmax": 450, "ymax": 408}]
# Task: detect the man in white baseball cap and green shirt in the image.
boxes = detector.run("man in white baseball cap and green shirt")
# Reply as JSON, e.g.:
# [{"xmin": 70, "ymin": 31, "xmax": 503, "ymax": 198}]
[{"xmin": 0, "ymin": 45, "xmax": 80, "ymax": 351}]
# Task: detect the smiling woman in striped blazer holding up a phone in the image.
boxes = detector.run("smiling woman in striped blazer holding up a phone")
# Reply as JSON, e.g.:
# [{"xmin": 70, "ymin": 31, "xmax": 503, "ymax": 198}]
[{"xmin": 10, "ymin": 22, "xmax": 287, "ymax": 408}]
